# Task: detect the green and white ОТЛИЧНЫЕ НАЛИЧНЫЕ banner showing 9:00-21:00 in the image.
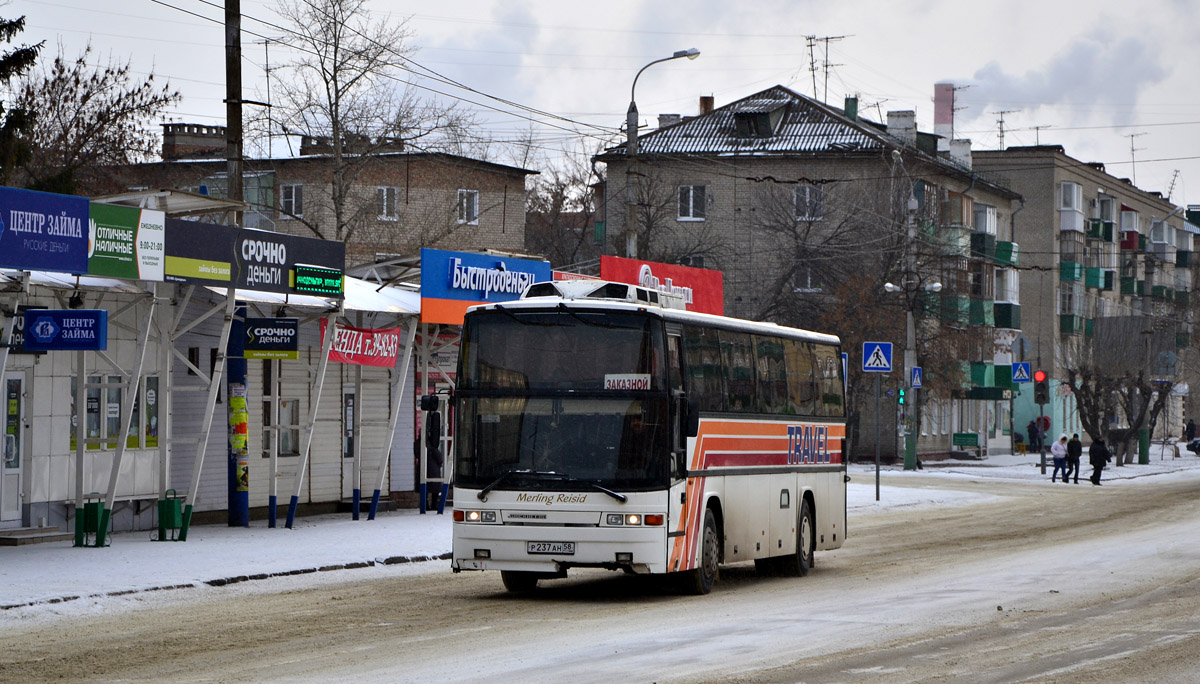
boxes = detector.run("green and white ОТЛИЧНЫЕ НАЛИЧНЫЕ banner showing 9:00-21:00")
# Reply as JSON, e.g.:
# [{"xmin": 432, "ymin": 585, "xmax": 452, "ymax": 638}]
[{"xmin": 88, "ymin": 203, "xmax": 167, "ymax": 281}]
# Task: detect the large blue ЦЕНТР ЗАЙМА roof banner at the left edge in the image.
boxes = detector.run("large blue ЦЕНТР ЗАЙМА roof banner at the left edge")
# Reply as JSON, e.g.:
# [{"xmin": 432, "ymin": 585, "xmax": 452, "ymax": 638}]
[{"xmin": 0, "ymin": 187, "xmax": 88, "ymax": 274}]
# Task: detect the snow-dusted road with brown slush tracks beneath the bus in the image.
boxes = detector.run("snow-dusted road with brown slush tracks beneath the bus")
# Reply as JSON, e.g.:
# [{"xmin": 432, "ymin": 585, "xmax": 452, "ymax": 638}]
[{"xmin": 0, "ymin": 473, "xmax": 1200, "ymax": 683}]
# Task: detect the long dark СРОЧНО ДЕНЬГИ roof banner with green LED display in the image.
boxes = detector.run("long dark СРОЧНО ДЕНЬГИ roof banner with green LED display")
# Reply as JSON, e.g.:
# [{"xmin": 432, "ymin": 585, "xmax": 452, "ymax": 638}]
[{"xmin": 166, "ymin": 218, "xmax": 346, "ymax": 292}]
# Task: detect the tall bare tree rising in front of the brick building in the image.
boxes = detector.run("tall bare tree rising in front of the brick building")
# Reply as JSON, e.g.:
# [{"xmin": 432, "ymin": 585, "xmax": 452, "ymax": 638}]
[{"xmin": 272, "ymin": 0, "xmax": 478, "ymax": 242}]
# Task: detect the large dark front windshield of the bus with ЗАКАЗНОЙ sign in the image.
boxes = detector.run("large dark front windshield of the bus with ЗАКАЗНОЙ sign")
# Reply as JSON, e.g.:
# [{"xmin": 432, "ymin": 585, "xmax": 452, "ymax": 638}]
[{"xmin": 455, "ymin": 308, "xmax": 668, "ymax": 491}]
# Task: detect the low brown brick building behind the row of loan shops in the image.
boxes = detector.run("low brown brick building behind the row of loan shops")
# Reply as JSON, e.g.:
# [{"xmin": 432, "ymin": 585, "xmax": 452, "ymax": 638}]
[{"xmin": 113, "ymin": 124, "xmax": 536, "ymax": 264}]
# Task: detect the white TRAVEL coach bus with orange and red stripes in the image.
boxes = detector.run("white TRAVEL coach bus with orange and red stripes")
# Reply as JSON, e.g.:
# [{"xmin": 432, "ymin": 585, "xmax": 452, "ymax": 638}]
[{"xmin": 446, "ymin": 281, "xmax": 846, "ymax": 594}]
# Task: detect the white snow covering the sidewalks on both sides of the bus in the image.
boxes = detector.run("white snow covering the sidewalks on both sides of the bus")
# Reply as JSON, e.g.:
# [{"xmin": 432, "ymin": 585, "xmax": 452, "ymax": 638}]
[{"xmin": 0, "ymin": 445, "xmax": 1200, "ymax": 625}]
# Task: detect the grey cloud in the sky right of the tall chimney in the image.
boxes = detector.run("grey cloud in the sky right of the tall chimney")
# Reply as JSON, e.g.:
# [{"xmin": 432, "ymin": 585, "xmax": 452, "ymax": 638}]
[{"xmin": 960, "ymin": 30, "xmax": 1171, "ymax": 124}]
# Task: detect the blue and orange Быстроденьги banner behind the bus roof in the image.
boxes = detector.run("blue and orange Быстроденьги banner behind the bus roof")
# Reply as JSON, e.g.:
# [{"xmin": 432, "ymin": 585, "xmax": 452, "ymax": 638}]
[{"xmin": 421, "ymin": 250, "xmax": 552, "ymax": 325}]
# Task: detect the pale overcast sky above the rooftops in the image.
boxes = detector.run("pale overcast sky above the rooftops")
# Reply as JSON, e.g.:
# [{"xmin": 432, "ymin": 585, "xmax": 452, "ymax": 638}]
[{"xmin": 9, "ymin": 0, "xmax": 1200, "ymax": 204}]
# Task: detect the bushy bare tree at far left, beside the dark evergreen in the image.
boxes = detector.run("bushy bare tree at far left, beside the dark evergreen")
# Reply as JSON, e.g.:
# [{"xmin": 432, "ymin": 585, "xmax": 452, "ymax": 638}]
[{"xmin": 17, "ymin": 46, "xmax": 180, "ymax": 194}]
